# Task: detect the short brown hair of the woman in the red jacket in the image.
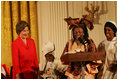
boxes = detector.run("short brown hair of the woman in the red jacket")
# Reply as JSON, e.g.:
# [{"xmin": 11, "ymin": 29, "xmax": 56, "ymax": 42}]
[{"xmin": 16, "ymin": 21, "xmax": 30, "ymax": 35}]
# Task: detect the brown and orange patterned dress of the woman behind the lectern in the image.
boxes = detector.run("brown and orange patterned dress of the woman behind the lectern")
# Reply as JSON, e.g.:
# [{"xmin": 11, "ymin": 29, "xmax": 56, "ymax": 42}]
[{"xmin": 62, "ymin": 39, "xmax": 101, "ymax": 79}]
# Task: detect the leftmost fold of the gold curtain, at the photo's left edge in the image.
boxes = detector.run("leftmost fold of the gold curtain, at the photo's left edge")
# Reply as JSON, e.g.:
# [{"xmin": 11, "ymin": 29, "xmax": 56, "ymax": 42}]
[{"xmin": 1, "ymin": 1, "xmax": 12, "ymax": 67}]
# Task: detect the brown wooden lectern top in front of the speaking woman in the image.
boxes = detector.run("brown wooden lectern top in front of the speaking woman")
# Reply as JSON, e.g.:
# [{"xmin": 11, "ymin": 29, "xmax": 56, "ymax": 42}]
[{"xmin": 61, "ymin": 52, "xmax": 105, "ymax": 62}]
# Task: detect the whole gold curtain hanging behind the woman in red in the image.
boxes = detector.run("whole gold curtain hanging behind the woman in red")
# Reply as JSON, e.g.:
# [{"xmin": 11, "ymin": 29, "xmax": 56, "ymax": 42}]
[{"xmin": 1, "ymin": 1, "xmax": 39, "ymax": 68}]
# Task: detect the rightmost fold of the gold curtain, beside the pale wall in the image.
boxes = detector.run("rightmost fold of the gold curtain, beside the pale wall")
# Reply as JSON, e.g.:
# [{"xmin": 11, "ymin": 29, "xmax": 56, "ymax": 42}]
[{"xmin": 29, "ymin": 1, "xmax": 38, "ymax": 55}]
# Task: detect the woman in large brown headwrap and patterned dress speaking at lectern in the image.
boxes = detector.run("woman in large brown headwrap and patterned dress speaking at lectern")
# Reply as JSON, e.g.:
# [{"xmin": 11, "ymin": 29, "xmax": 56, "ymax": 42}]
[{"xmin": 61, "ymin": 16, "xmax": 101, "ymax": 79}]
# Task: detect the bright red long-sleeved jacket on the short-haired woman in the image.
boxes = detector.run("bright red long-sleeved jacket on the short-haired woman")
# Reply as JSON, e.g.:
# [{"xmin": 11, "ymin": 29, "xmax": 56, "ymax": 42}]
[{"xmin": 12, "ymin": 37, "xmax": 39, "ymax": 78}]
